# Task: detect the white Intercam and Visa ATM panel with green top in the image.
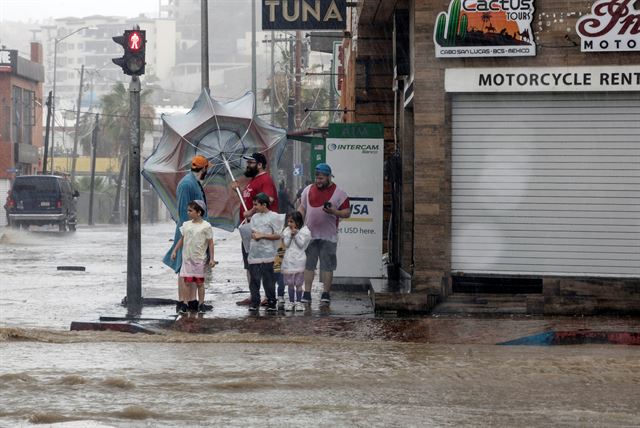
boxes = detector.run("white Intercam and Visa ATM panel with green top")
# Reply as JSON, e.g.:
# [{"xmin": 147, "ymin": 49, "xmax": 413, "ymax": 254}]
[{"xmin": 326, "ymin": 123, "xmax": 384, "ymax": 278}]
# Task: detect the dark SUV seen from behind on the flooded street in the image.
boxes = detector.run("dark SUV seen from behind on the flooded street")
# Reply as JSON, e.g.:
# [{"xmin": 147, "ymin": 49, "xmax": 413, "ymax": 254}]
[{"xmin": 7, "ymin": 175, "xmax": 80, "ymax": 232}]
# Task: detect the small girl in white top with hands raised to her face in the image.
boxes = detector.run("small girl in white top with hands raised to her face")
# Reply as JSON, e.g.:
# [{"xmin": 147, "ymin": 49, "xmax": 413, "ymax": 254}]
[{"xmin": 280, "ymin": 211, "xmax": 311, "ymax": 311}]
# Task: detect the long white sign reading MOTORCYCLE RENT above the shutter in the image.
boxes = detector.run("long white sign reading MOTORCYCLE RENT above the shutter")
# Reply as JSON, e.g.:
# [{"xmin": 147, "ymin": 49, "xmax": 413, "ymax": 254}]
[{"xmin": 444, "ymin": 65, "xmax": 640, "ymax": 92}]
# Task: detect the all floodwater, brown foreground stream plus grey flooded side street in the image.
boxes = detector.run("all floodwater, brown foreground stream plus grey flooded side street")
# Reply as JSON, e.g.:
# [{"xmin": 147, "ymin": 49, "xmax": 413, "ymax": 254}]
[{"xmin": 0, "ymin": 225, "xmax": 640, "ymax": 428}]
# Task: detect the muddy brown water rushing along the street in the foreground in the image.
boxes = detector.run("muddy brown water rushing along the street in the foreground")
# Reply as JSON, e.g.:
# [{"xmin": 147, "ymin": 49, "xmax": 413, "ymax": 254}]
[{"xmin": 0, "ymin": 328, "xmax": 640, "ymax": 427}]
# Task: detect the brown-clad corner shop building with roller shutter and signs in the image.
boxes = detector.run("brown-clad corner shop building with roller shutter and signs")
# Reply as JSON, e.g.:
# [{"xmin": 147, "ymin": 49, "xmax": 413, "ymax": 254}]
[{"xmin": 350, "ymin": 0, "xmax": 640, "ymax": 314}]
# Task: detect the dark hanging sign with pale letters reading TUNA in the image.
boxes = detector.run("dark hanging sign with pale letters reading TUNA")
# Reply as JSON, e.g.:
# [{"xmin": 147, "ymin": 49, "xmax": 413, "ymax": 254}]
[{"xmin": 262, "ymin": 0, "xmax": 347, "ymax": 30}]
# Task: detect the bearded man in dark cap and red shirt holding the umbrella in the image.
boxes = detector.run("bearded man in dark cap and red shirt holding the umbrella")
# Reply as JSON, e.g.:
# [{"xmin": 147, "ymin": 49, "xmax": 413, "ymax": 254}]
[{"xmin": 231, "ymin": 152, "xmax": 278, "ymax": 305}]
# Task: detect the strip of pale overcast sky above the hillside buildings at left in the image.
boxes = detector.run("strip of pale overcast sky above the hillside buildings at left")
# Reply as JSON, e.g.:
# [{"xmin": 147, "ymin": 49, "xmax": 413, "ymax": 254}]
[{"xmin": 0, "ymin": 0, "xmax": 159, "ymax": 22}]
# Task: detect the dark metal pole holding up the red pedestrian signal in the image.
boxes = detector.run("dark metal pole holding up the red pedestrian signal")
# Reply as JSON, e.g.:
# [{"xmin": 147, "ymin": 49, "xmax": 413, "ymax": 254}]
[{"xmin": 127, "ymin": 76, "xmax": 142, "ymax": 312}]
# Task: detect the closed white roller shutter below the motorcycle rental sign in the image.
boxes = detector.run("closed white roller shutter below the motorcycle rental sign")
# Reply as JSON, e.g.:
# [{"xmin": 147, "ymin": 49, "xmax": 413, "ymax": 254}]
[{"xmin": 451, "ymin": 93, "xmax": 640, "ymax": 277}]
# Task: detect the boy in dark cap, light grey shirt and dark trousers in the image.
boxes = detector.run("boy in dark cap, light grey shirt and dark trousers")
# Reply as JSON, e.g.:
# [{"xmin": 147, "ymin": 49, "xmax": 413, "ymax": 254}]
[{"xmin": 247, "ymin": 193, "xmax": 284, "ymax": 312}]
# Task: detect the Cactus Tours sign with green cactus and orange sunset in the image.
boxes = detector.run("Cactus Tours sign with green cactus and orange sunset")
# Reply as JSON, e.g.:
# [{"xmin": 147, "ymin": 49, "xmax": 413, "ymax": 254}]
[{"xmin": 433, "ymin": 0, "xmax": 536, "ymax": 58}]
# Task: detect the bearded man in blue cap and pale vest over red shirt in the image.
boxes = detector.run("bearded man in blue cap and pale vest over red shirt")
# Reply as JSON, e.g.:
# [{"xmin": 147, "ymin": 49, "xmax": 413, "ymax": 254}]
[{"xmin": 298, "ymin": 163, "xmax": 351, "ymax": 306}]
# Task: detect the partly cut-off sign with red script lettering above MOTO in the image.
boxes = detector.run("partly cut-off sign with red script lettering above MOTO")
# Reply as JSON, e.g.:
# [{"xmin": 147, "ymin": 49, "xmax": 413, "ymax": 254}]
[{"xmin": 576, "ymin": 0, "xmax": 640, "ymax": 52}]
